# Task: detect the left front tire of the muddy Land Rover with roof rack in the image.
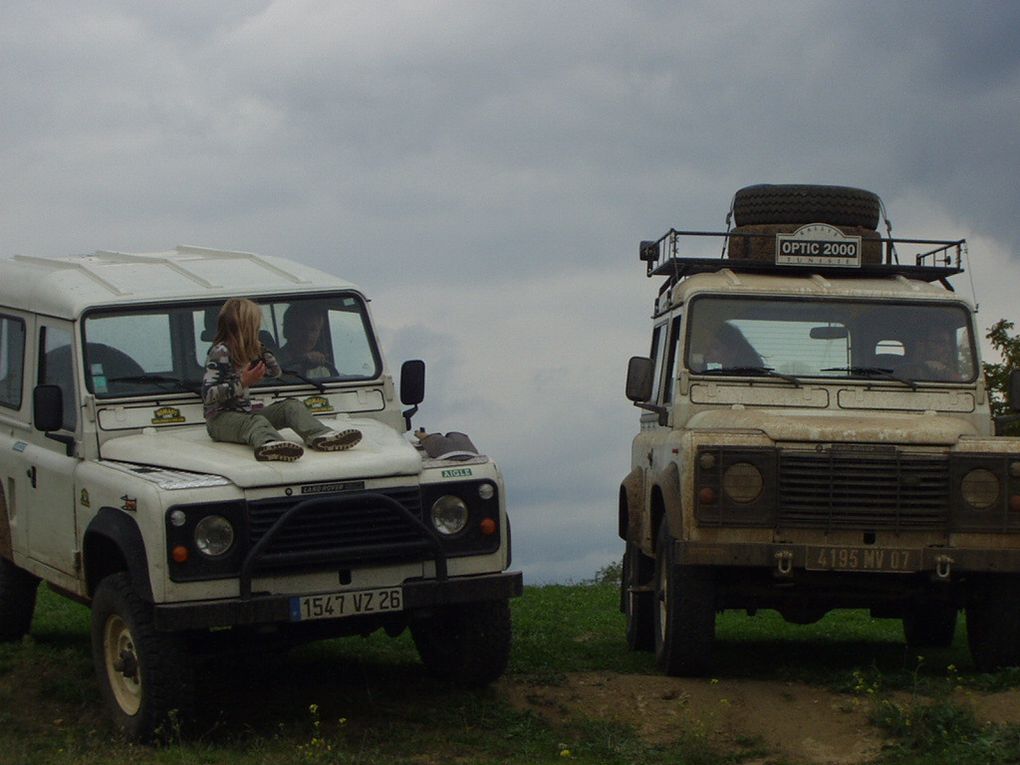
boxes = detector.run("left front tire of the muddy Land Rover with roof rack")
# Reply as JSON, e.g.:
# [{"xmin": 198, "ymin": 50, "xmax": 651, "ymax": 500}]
[{"xmin": 653, "ymin": 519, "xmax": 715, "ymax": 677}]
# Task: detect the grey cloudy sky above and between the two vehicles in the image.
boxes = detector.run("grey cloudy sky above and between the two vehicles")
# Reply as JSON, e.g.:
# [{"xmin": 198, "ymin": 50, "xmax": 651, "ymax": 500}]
[{"xmin": 0, "ymin": 0, "xmax": 1020, "ymax": 583}]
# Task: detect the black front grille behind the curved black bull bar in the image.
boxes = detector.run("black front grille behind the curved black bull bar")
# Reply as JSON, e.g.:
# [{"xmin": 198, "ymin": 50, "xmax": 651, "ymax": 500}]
[{"xmin": 248, "ymin": 487, "xmax": 431, "ymax": 569}]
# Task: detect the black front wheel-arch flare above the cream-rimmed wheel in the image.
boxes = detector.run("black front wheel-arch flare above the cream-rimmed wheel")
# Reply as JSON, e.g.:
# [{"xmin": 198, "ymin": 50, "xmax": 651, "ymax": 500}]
[{"xmin": 83, "ymin": 507, "xmax": 152, "ymax": 603}]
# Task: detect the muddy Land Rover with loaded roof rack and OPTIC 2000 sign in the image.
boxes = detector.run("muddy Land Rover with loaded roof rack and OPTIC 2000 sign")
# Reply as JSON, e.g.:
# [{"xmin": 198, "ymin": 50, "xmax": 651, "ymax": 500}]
[{"xmin": 619, "ymin": 186, "xmax": 1020, "ymax": 675}]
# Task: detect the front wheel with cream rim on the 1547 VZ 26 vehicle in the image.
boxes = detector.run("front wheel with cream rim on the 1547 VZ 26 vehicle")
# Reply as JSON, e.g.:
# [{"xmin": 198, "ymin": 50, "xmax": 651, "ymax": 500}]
[{"xmin": 92, "ymin": 572, "xmax": 194, "ymax": 744}]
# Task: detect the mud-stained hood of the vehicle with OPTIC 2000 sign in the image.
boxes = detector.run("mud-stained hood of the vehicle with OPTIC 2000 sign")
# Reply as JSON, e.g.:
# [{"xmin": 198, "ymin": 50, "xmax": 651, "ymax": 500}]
[{"xmin": 687, "ymin": 409, "xmax": 978, "ymax": 446}]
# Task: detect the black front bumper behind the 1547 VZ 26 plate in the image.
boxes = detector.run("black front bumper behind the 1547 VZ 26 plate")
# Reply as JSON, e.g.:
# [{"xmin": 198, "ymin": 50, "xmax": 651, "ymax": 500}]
[{"xmin": 153, "ymin": 571, "xmax": 523, "ymax": 632}]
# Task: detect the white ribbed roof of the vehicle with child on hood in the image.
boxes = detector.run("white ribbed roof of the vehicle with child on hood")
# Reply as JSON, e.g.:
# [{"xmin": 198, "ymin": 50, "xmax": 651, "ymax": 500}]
[{"xmin": 0, "ymin": 247, "xmax": 357, "ymax": 318}]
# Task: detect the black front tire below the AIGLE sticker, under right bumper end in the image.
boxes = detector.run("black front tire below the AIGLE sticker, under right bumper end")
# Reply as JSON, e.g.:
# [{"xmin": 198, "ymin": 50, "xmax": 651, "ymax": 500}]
[{"xmin": 411, "ymin": 600, "xmax": 511, "ymax": 686}]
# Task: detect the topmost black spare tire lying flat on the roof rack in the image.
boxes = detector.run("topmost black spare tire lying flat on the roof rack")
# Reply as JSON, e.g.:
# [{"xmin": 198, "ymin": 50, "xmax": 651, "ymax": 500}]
[{"xmin": 733, "ymin": 184, "xmax": 881, "ymax": 230}]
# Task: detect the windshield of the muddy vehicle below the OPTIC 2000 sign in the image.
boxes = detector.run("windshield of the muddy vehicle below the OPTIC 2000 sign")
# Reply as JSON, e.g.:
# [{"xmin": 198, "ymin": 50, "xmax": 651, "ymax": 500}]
[{"xmin": 684, "ymin": 296, "xmax": 977, "ymax": 383}]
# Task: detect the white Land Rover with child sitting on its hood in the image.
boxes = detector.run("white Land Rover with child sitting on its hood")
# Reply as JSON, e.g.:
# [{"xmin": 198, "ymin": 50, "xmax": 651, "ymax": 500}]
[{"xmin": 0, "ymin": 248, "xmax": 521, "ymax": 740}]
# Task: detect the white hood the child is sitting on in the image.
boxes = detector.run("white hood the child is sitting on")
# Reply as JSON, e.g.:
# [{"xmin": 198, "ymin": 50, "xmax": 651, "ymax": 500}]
[{"xmin": 102, "ymin": 417, "xmax": 421, "ymax": 488}]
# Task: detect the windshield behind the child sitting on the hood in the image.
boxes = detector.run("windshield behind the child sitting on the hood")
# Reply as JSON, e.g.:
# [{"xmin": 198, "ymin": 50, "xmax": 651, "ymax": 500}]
[{"xmin": 84, "ymin": 294, "xmax": 381, "ymax": 398}]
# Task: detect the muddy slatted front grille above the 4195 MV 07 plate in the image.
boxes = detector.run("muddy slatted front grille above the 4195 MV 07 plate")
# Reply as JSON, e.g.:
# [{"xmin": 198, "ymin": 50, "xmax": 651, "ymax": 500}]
[{"xmin": 778, "ymin": 450, "xmax": 950, "ymax": 530}]
